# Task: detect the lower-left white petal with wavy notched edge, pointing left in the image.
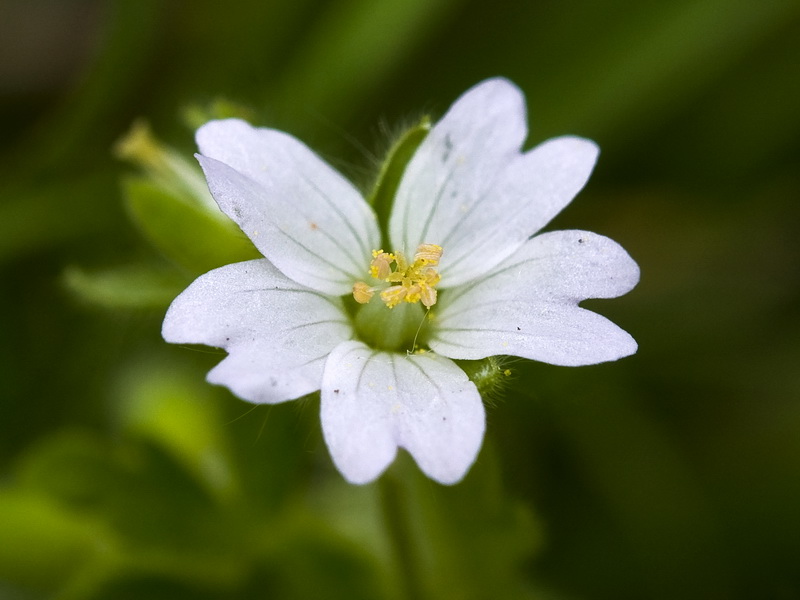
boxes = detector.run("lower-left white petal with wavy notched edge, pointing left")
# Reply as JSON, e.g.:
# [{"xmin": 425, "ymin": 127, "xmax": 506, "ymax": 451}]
[{"xmin": 162, "ymin": 259, "xmax": 352, "ymax": 403}]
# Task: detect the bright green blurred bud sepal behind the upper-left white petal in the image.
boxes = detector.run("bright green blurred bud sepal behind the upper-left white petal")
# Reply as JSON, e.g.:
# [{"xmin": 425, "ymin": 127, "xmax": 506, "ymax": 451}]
[{"xmin": 123, "ymin": 177, "xmax": 261, "ymax": 274}]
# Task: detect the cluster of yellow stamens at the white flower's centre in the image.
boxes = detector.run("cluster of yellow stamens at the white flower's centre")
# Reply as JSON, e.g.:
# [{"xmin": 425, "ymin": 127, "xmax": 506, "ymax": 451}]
[{"xmin": 353, "ymin": 244, "xmax": 442, "ymax": 308}]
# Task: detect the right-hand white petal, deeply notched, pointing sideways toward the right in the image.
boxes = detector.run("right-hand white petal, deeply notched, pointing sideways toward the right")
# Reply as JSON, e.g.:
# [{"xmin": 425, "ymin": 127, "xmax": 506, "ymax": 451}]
[{"xmin": 429, "ymin": 231, "xmax": 639, "ymax": 366}]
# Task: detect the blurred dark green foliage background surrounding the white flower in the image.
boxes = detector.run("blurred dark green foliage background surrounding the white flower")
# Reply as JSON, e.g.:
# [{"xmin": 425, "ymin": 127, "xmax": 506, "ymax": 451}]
[{"xmin": 0, "ymin": 0, "xmax": 800, "ymax": 600}]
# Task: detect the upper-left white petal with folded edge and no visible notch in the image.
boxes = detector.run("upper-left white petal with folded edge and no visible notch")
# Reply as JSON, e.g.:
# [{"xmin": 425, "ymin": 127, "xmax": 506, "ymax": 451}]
[{"xmin": 197, "ymin": 119, "xmax": 380, "ymax": 295}]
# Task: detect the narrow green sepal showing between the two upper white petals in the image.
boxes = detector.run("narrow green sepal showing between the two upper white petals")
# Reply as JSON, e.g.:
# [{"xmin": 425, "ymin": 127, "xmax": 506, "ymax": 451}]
[{"xmin": 367, "ymin": 116, "xmax": 431, "ymax": 247}]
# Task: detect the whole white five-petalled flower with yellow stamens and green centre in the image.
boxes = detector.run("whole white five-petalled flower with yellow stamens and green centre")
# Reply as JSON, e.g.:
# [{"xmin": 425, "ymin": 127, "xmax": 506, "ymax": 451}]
[{"xmin": 163, "ymin": 79, "xmax": 639, "ymax": 483}]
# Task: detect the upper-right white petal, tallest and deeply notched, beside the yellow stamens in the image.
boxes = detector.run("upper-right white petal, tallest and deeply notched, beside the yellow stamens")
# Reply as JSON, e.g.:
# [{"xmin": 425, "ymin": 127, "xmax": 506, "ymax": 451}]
[{"xmin": 389, "ymin": 79, "xmax": 598, "ymax": 288}]
